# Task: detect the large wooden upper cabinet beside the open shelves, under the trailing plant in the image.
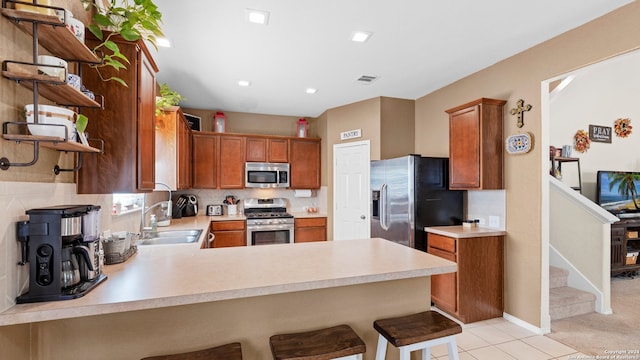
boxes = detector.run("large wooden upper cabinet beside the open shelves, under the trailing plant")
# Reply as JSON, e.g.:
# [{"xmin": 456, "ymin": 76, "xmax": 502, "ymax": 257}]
[{"xmin": 76, "ymin": 34, "xmax": 158, "ymax": 194}]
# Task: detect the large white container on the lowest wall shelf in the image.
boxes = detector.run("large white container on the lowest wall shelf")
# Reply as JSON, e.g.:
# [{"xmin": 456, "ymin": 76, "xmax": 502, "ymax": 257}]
[{"xmin": 24, "ymin": 104, "xmax": 76, "ymax": 141}]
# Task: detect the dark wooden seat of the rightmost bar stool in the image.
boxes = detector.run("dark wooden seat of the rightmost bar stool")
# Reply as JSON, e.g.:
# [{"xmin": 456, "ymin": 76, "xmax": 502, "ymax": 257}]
[{"xmin": 373, "ymin": 311, "xmax": 462, "ymax": 347}]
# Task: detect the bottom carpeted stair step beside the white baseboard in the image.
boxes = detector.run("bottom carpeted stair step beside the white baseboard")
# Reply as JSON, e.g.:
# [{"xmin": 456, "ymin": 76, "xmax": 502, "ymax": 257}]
[{"xmin": 549, "ymin": 286, "xmax": 596, "ymax": 320}]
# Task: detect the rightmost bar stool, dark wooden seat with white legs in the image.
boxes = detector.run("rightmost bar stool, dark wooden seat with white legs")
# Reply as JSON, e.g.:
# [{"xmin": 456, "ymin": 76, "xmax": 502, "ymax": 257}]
[{"xmin": 373, "ymin": 311, "xmax": 462, "ymax": 360}]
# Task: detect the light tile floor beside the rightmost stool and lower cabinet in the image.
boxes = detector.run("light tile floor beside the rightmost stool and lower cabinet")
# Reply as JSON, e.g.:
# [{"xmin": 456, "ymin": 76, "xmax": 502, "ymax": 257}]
[{"xmin": 431, "ymin": 318, "xmax": 590, "ymax": 360}]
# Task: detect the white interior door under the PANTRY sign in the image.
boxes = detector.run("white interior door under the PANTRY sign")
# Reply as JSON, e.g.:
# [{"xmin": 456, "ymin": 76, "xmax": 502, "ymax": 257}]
[{"xmin": 333, "ymin": 140, "xmax": 371, "ymax": 240}]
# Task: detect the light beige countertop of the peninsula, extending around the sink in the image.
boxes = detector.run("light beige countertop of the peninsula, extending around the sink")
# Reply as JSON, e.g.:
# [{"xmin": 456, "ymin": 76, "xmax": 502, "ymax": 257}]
[{"xmin": 0, "ymin": 236, "xmax": 457, "ymax": 326}]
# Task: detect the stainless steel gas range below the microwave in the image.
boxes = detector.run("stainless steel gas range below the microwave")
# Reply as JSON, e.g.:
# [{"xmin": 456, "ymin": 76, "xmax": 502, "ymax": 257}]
[{"xmin": 243, "ymin": 198, "xmax": 294, "ymax": 246}]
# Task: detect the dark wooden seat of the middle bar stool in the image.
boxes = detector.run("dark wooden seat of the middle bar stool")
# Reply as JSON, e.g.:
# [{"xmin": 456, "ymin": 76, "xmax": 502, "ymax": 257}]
[{"xmin": 269, "ymin": 325, "xmax": 366, "ymax": 360}]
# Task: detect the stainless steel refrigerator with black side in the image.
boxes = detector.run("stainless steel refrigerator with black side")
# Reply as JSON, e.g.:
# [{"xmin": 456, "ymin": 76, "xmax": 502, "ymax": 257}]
[{"xmin": 371, "ymin": 155, "xmax": 464, "ymax": 251}]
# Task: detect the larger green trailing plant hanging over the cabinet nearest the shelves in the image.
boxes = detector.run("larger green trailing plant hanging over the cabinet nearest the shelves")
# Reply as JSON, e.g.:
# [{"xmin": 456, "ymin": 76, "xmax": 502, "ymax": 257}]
[{"xmin": 80, "ymin": 0, "xmax": 163, "ymax": 86}]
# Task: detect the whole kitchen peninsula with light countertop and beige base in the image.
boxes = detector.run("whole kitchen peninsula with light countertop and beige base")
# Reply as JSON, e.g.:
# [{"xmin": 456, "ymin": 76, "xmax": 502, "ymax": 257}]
[{"xmin": 0, "ymin": 229, "xmax": 456, "ymax": 359}]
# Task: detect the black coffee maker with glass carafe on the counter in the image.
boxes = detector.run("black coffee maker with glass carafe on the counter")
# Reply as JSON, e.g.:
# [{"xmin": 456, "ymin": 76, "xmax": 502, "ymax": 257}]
[{"xmin": 16, "ymin": 205, "xmax": 107, "ymax": 304}]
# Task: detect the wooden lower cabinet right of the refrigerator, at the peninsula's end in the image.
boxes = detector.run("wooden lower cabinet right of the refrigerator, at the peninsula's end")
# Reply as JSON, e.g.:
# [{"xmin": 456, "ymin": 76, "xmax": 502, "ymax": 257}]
[{"xmin": 427, "ymin": 233, "xmax": 504, "ymax": 323}]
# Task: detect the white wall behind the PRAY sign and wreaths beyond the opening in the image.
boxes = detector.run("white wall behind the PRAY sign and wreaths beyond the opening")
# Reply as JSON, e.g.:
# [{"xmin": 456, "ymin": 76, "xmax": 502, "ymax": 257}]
[{"xmin": 549, "ymin": 51, "xmax": 640, "ymax": 200}]
